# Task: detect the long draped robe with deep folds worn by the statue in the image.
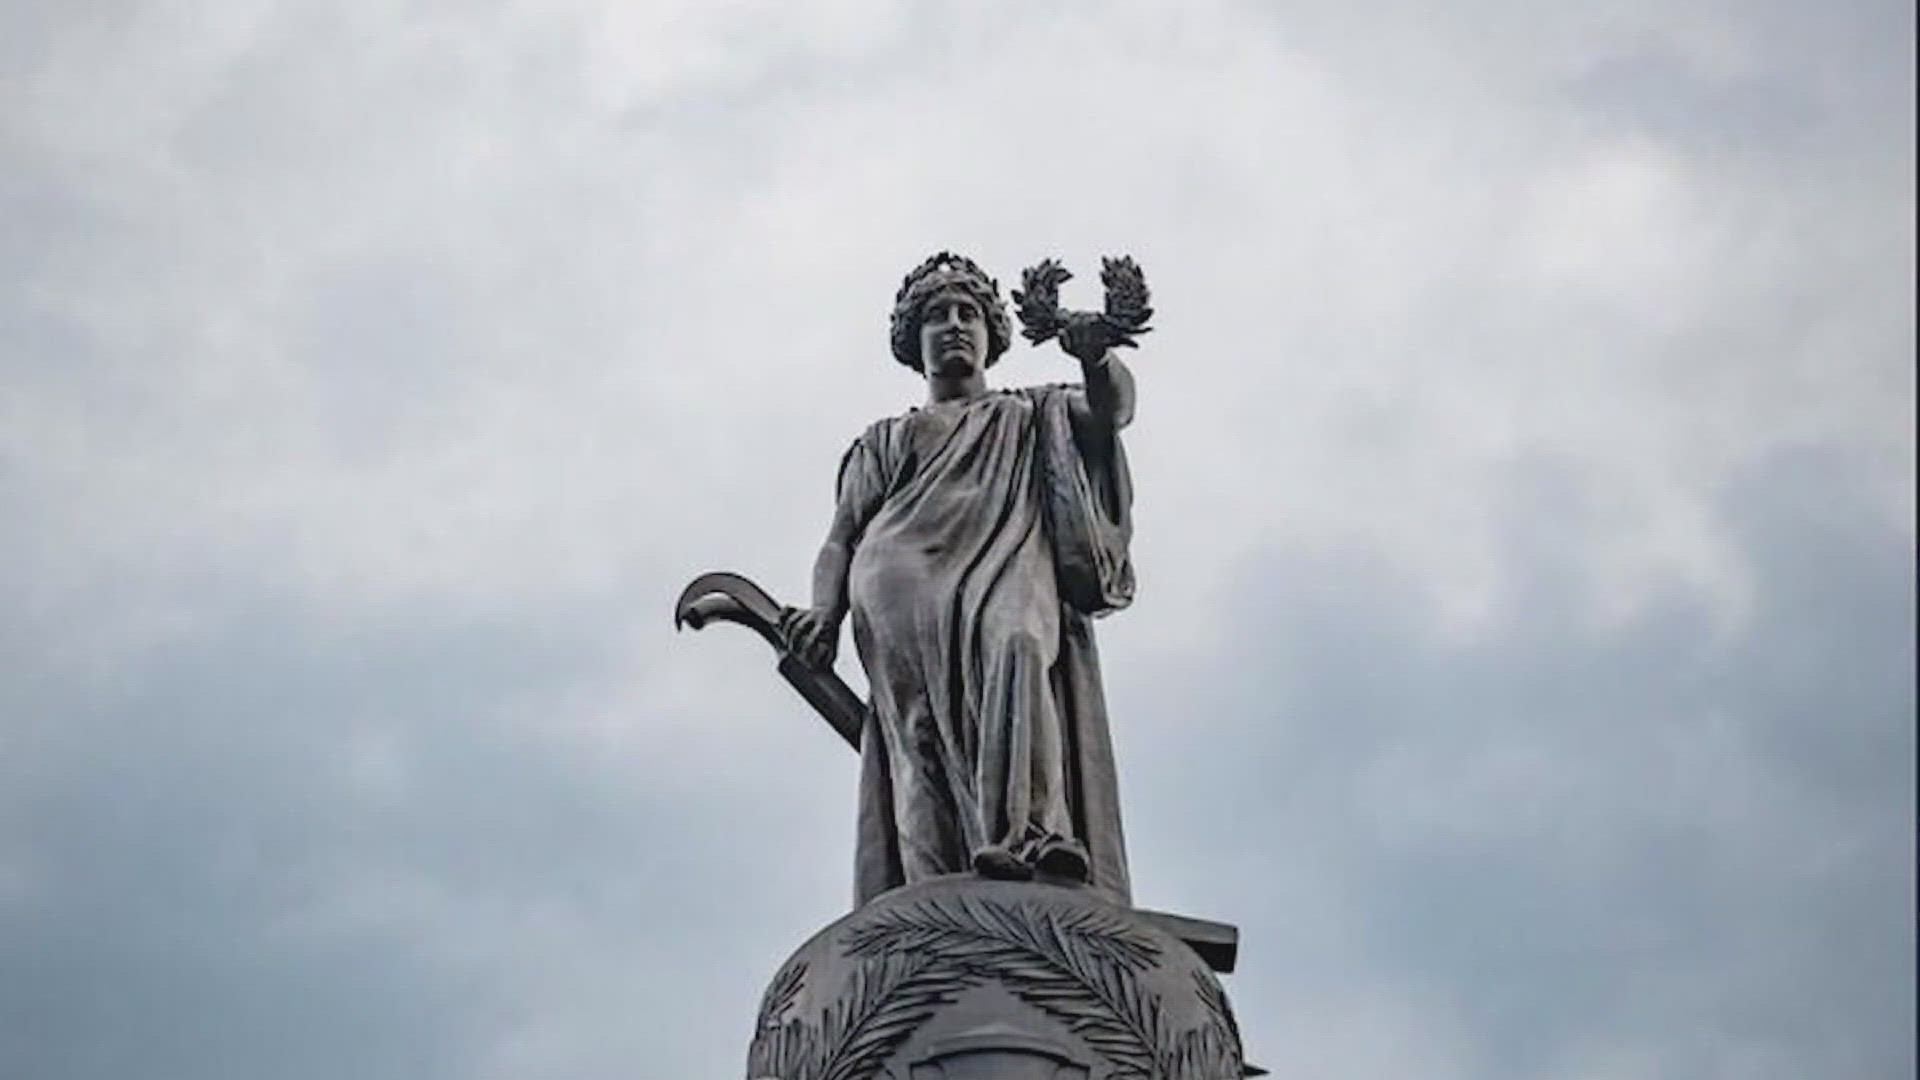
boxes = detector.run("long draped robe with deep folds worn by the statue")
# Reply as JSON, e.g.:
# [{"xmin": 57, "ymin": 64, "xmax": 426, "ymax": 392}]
[{"xmin": 837, "ymin": 386, "xmax": 1133, "ymax": 903}]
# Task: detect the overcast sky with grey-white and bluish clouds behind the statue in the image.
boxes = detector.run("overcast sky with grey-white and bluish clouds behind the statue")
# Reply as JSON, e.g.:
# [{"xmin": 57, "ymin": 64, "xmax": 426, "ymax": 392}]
[{"xmin": 0, "ymin": 0, "xmax": 1914, "ymax": 1080}]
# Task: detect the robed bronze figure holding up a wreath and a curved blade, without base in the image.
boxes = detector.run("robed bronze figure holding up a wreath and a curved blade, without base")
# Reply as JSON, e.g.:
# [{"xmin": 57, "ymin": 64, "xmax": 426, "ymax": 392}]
[{"xmin": 682, "ymin": 252, "xmax": 1152, "ymax": 903}]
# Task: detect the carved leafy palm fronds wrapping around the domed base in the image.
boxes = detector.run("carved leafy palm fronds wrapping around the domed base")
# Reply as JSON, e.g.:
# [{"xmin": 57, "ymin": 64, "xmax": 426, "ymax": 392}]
[{"xmin": 747, "ymin": 896, "xmax": 1242, "ymax": 1080}]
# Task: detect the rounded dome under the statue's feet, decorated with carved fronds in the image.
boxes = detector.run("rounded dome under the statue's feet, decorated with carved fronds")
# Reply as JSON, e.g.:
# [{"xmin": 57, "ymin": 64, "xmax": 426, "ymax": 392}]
[{"xmin": 747, "ymin": 874, "xmax": 1252, "ymax": 1080}]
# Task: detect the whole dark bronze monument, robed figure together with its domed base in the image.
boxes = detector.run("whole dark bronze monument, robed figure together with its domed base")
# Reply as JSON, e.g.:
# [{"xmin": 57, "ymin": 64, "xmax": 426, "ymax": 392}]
[{"xmin": 676, "ymin": 252, "xmax": 1258, "ymax": 1080}]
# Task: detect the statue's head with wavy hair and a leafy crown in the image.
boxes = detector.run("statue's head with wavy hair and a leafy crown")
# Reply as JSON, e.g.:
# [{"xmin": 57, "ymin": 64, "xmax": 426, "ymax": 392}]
[{"xmin": 893, "ymin": 252, "xmax": 1014, "ymax": 375}]
